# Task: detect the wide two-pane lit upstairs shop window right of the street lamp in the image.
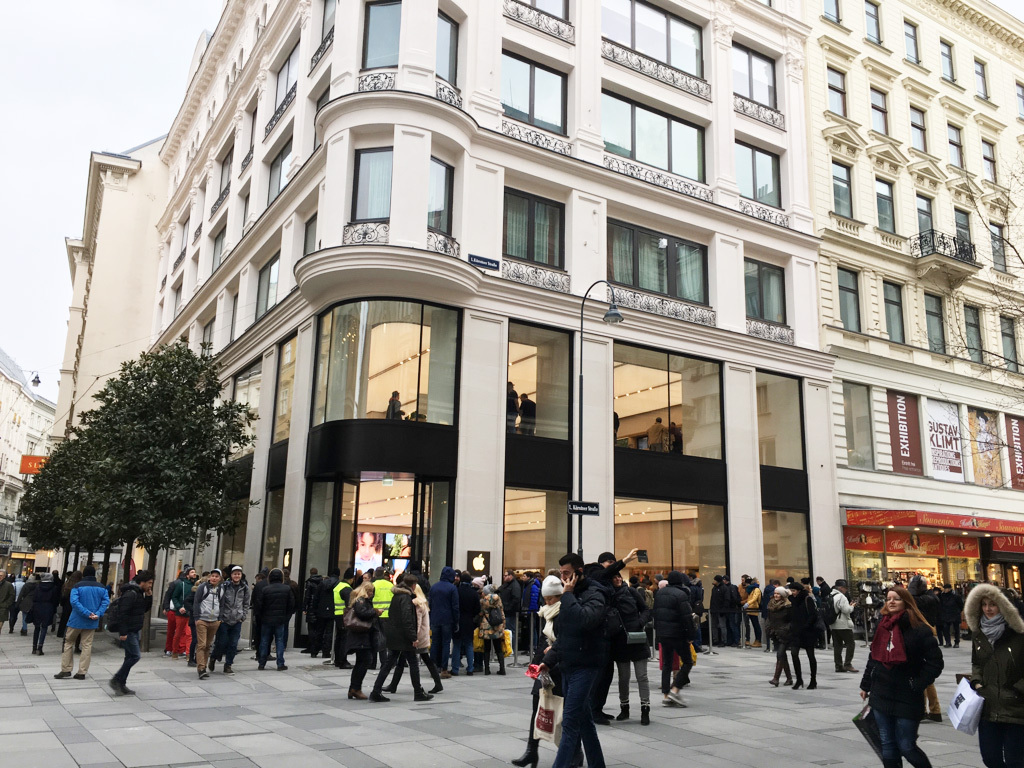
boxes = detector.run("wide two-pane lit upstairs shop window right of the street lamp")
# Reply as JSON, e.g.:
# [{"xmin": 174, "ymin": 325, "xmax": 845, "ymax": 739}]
[{"xmin": 612, "ymin": 344, "xmax": 722, "ymax": 459}]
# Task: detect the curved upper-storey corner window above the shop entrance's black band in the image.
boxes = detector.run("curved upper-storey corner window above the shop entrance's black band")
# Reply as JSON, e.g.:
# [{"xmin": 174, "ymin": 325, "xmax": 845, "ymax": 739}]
[{"xmin": 313, "ymin": 300, "xmax": 459, "ymax": 424}]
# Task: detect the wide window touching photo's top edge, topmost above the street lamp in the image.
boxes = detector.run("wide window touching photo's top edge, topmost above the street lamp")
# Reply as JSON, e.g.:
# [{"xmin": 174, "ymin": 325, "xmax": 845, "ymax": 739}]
[{"xmin": 601, "ymin": 0, "xmax": 703, "ymax": 77}]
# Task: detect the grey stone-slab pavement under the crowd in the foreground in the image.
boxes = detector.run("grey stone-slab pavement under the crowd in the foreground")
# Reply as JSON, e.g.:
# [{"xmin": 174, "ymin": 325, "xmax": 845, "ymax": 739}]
[{"xmin": 0, "ymin": 632, "xmax": 982, "ymax": 768}]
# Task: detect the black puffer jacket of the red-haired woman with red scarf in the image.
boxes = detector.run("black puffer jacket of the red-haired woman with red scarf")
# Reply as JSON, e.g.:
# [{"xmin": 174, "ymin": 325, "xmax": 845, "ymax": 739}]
[{"xmin": 860, "ymin": 611, "xmax": 943, "ymax": 720}]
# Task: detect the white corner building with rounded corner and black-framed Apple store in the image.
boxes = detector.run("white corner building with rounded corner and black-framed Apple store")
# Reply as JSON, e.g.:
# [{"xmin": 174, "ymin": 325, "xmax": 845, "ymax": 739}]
[{"xmin": 154, "ymin": 0, "xmax": 841, "ymax": 606}]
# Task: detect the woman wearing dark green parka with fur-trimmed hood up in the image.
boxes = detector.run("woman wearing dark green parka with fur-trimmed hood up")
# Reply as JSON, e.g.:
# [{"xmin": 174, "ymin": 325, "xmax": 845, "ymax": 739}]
[{"xmin": 964, "ymin": 584, "xmax": 1024, "ymax": 768}]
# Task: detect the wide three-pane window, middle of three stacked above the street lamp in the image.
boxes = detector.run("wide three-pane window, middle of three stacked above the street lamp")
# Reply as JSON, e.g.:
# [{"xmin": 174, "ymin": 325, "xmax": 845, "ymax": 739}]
[{"xmin": 601, "ymin": 93, "xmax": 705, "ymax": 181}]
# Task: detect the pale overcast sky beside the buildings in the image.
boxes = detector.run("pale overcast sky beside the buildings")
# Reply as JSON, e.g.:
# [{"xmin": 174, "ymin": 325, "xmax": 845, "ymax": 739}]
[{"xmin": 0, "ymin": 0, "xmax": 1024, "ymax": 409}]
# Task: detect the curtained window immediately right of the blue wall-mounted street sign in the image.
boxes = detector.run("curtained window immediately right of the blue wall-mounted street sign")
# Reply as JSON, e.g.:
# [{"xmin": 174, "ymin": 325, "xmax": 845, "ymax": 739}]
[{"xmin": 503, "ymin": 187, "xmax": 565, "ymax": 269}]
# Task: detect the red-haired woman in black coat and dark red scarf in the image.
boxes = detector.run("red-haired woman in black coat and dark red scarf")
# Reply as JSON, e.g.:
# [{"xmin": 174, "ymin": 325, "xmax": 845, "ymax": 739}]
[{"xmin": 860, "ymin": 587, "xmax": 937, "ymax": 768}]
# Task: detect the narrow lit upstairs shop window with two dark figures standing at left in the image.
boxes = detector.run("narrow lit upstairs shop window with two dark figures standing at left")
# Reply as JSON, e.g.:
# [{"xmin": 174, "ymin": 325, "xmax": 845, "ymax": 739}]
[{"xmin": 506, "ymin": 322, "xmax": 572, "ymax": 440}]
